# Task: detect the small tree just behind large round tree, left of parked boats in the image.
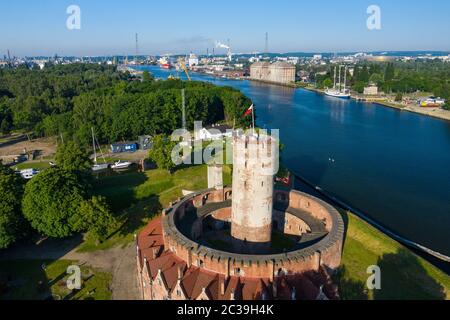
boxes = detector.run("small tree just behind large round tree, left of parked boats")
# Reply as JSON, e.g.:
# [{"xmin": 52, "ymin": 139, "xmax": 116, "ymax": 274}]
[{"xmin": 55, "ymin": 141, "xmax": 92, "ymax": 172}]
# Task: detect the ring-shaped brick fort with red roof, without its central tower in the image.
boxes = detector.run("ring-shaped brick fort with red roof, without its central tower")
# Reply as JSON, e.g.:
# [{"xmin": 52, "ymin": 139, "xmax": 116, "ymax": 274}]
[{"xmin": 136, "ymin": 189, "xmax": 344, "ymax": 300}]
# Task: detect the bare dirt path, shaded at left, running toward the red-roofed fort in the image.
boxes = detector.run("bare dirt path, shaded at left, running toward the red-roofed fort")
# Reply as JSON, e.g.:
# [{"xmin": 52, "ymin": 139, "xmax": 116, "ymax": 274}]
[{"xmin": 0, "ymin": 239, "xmax": 139, "ymax": 300}]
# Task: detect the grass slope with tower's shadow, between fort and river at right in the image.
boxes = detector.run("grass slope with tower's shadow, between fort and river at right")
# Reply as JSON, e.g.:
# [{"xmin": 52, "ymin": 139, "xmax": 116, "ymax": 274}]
[{"xmin": 336, "ymin": 214, "xmax": 450, "ymax": 299}]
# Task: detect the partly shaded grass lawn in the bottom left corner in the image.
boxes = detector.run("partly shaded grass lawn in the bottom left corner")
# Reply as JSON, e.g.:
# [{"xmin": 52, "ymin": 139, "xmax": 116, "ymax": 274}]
[{"xmin": 0, "ymin": 260, "xmax": 112, "ymax": 300}]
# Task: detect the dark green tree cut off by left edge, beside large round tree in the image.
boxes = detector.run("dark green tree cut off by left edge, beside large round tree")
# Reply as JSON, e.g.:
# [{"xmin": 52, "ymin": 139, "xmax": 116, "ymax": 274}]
[{"xmin": 0, "ymin": 161, "xmax": 28, "ymax": 249}]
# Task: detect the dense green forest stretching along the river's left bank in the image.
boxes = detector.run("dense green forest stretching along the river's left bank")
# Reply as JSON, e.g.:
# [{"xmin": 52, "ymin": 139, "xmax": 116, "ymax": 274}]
[{"xmin": 0, "ymin": 64, "xmax": 251, "ymax": 145}]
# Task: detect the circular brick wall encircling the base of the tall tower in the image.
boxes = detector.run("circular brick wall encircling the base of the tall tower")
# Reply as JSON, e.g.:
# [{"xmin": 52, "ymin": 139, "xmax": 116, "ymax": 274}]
[{"xmin": 162, "ymin": 188, "xmax": 344, "ymax": 278}]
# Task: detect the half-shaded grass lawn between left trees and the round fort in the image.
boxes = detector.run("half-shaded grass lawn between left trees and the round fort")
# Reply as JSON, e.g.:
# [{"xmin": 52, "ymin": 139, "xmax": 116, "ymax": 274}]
[{"xmin": 78, "ymin": 165, "xmax": 231, "ymax": 252}]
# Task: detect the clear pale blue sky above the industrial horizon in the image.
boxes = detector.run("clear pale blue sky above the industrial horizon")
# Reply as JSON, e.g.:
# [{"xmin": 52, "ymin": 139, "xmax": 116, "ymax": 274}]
[{"xmin": 0, "ymin": 0, "xmax": 450, "ymax": 56}]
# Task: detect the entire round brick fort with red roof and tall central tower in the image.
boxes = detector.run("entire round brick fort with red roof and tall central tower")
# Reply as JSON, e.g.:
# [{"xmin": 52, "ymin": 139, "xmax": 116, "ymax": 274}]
[{"xmin": 136, "ymin": 131, "xmax": 344, "ymax": 300}]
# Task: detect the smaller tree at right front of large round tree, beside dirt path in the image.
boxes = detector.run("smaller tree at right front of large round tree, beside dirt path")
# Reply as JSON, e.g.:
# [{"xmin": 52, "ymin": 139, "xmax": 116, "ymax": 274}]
[{"xmin": 74, "ymin": 196, "xmax": 116, "ymax": 241}]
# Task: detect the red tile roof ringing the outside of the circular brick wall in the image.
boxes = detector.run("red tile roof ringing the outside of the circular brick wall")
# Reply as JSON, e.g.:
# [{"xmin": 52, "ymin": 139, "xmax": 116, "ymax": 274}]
[{"xmin": 137, "ymin": 218, "xmax": 337, "ymax": 300}]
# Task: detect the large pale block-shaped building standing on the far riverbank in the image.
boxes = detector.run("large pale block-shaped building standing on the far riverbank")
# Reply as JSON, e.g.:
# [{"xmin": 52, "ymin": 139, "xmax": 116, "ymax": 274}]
[{"xmin": 250, "ymin": 61, "xmax": 295, "ymax": 84}]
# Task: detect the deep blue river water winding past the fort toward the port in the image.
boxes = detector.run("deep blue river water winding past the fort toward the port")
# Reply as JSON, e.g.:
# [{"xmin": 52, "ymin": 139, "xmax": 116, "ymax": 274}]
[{"xmin": 139, "ymin": 66, "xmax": 450, "ymax": 256}]
